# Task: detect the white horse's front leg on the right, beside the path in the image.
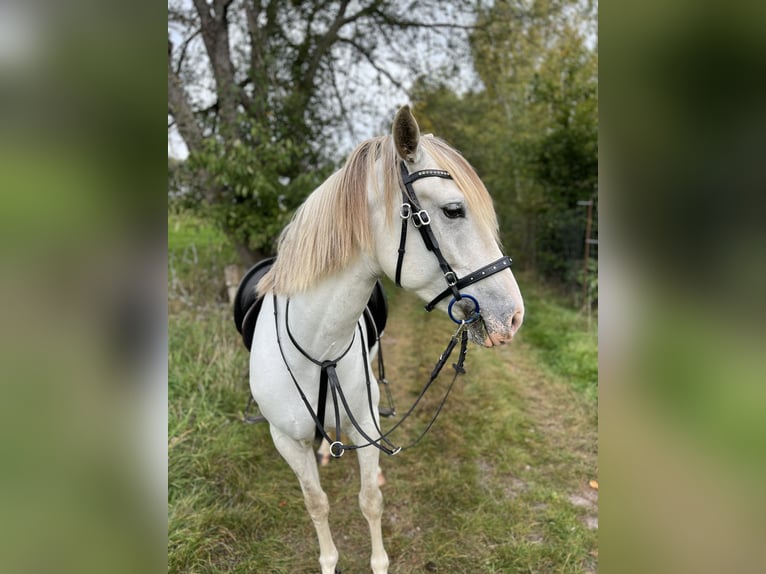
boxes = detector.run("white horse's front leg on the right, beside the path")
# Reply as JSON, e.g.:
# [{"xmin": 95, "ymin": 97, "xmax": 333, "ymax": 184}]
[{"xmin": 349, "ymin": 423, "xmax": 388, "ymax": 574}]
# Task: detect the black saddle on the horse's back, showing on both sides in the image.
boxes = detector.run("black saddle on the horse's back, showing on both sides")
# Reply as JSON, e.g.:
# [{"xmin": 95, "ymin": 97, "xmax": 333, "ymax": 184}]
[{"xmin": 234, "ymin": 257, "xmax": 388, "ymax": 351}]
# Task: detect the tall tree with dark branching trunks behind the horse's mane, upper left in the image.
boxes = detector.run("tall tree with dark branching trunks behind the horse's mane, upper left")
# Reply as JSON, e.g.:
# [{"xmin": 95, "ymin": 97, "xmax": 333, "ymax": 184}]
[{"xmin": 168, "ymin": 0, "xmax": 480, "ymax": 262}]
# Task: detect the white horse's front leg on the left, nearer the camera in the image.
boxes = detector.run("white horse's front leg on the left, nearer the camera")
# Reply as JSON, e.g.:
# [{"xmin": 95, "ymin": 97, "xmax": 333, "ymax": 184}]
[{"xmin": 271, "ymin": 425, "xmax": 338, "ymax": 574}]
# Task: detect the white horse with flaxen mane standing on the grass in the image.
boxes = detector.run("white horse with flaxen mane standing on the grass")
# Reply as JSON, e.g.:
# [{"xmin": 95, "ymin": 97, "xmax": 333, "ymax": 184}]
[{"xmin": 250, "ymin": 106, "xmax": 524, "ymax": 574}]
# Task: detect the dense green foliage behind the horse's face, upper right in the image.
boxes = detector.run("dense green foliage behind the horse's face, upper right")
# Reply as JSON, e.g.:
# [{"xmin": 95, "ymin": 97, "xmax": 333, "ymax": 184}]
[{"xmin": 412, "ymin": 0, "xmax": 598, "ymax": 302}]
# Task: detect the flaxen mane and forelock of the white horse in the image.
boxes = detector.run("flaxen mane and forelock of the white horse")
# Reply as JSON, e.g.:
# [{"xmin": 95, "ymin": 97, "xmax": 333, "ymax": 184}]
[{"xmin": 258, "ymin": 135, "xmax": 498, "ymax": 296}]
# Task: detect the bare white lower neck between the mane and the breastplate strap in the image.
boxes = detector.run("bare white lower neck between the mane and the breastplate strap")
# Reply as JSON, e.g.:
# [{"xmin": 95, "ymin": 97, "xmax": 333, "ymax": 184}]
[{"xmin": 289, "ymin": 258, "xmax": 376, "ymax": 361}]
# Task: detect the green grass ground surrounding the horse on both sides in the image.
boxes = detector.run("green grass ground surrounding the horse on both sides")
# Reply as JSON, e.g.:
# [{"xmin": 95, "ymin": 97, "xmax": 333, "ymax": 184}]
[{"xmin": 168, "ymin": 216, "xmax": 598, "ymax": 574}]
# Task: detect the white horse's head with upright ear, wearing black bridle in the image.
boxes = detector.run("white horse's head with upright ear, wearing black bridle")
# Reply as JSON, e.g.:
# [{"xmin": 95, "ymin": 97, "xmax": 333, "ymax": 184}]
[{"xmin": 373, "ymin": 106, "xmax": 524, "ymax": 347}]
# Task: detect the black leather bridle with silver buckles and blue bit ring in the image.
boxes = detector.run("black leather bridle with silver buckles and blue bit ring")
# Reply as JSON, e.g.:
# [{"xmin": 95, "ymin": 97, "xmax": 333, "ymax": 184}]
[{"xmin": 396, "ymin": 161, "xmax": 512, "ymax": 323}]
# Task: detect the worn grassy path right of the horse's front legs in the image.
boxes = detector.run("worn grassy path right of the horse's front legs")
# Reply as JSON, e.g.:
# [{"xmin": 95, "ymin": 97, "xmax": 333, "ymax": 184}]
[{"xmin": 372, "ymin": 293, "xmax": 597, "ymax": 572}]
